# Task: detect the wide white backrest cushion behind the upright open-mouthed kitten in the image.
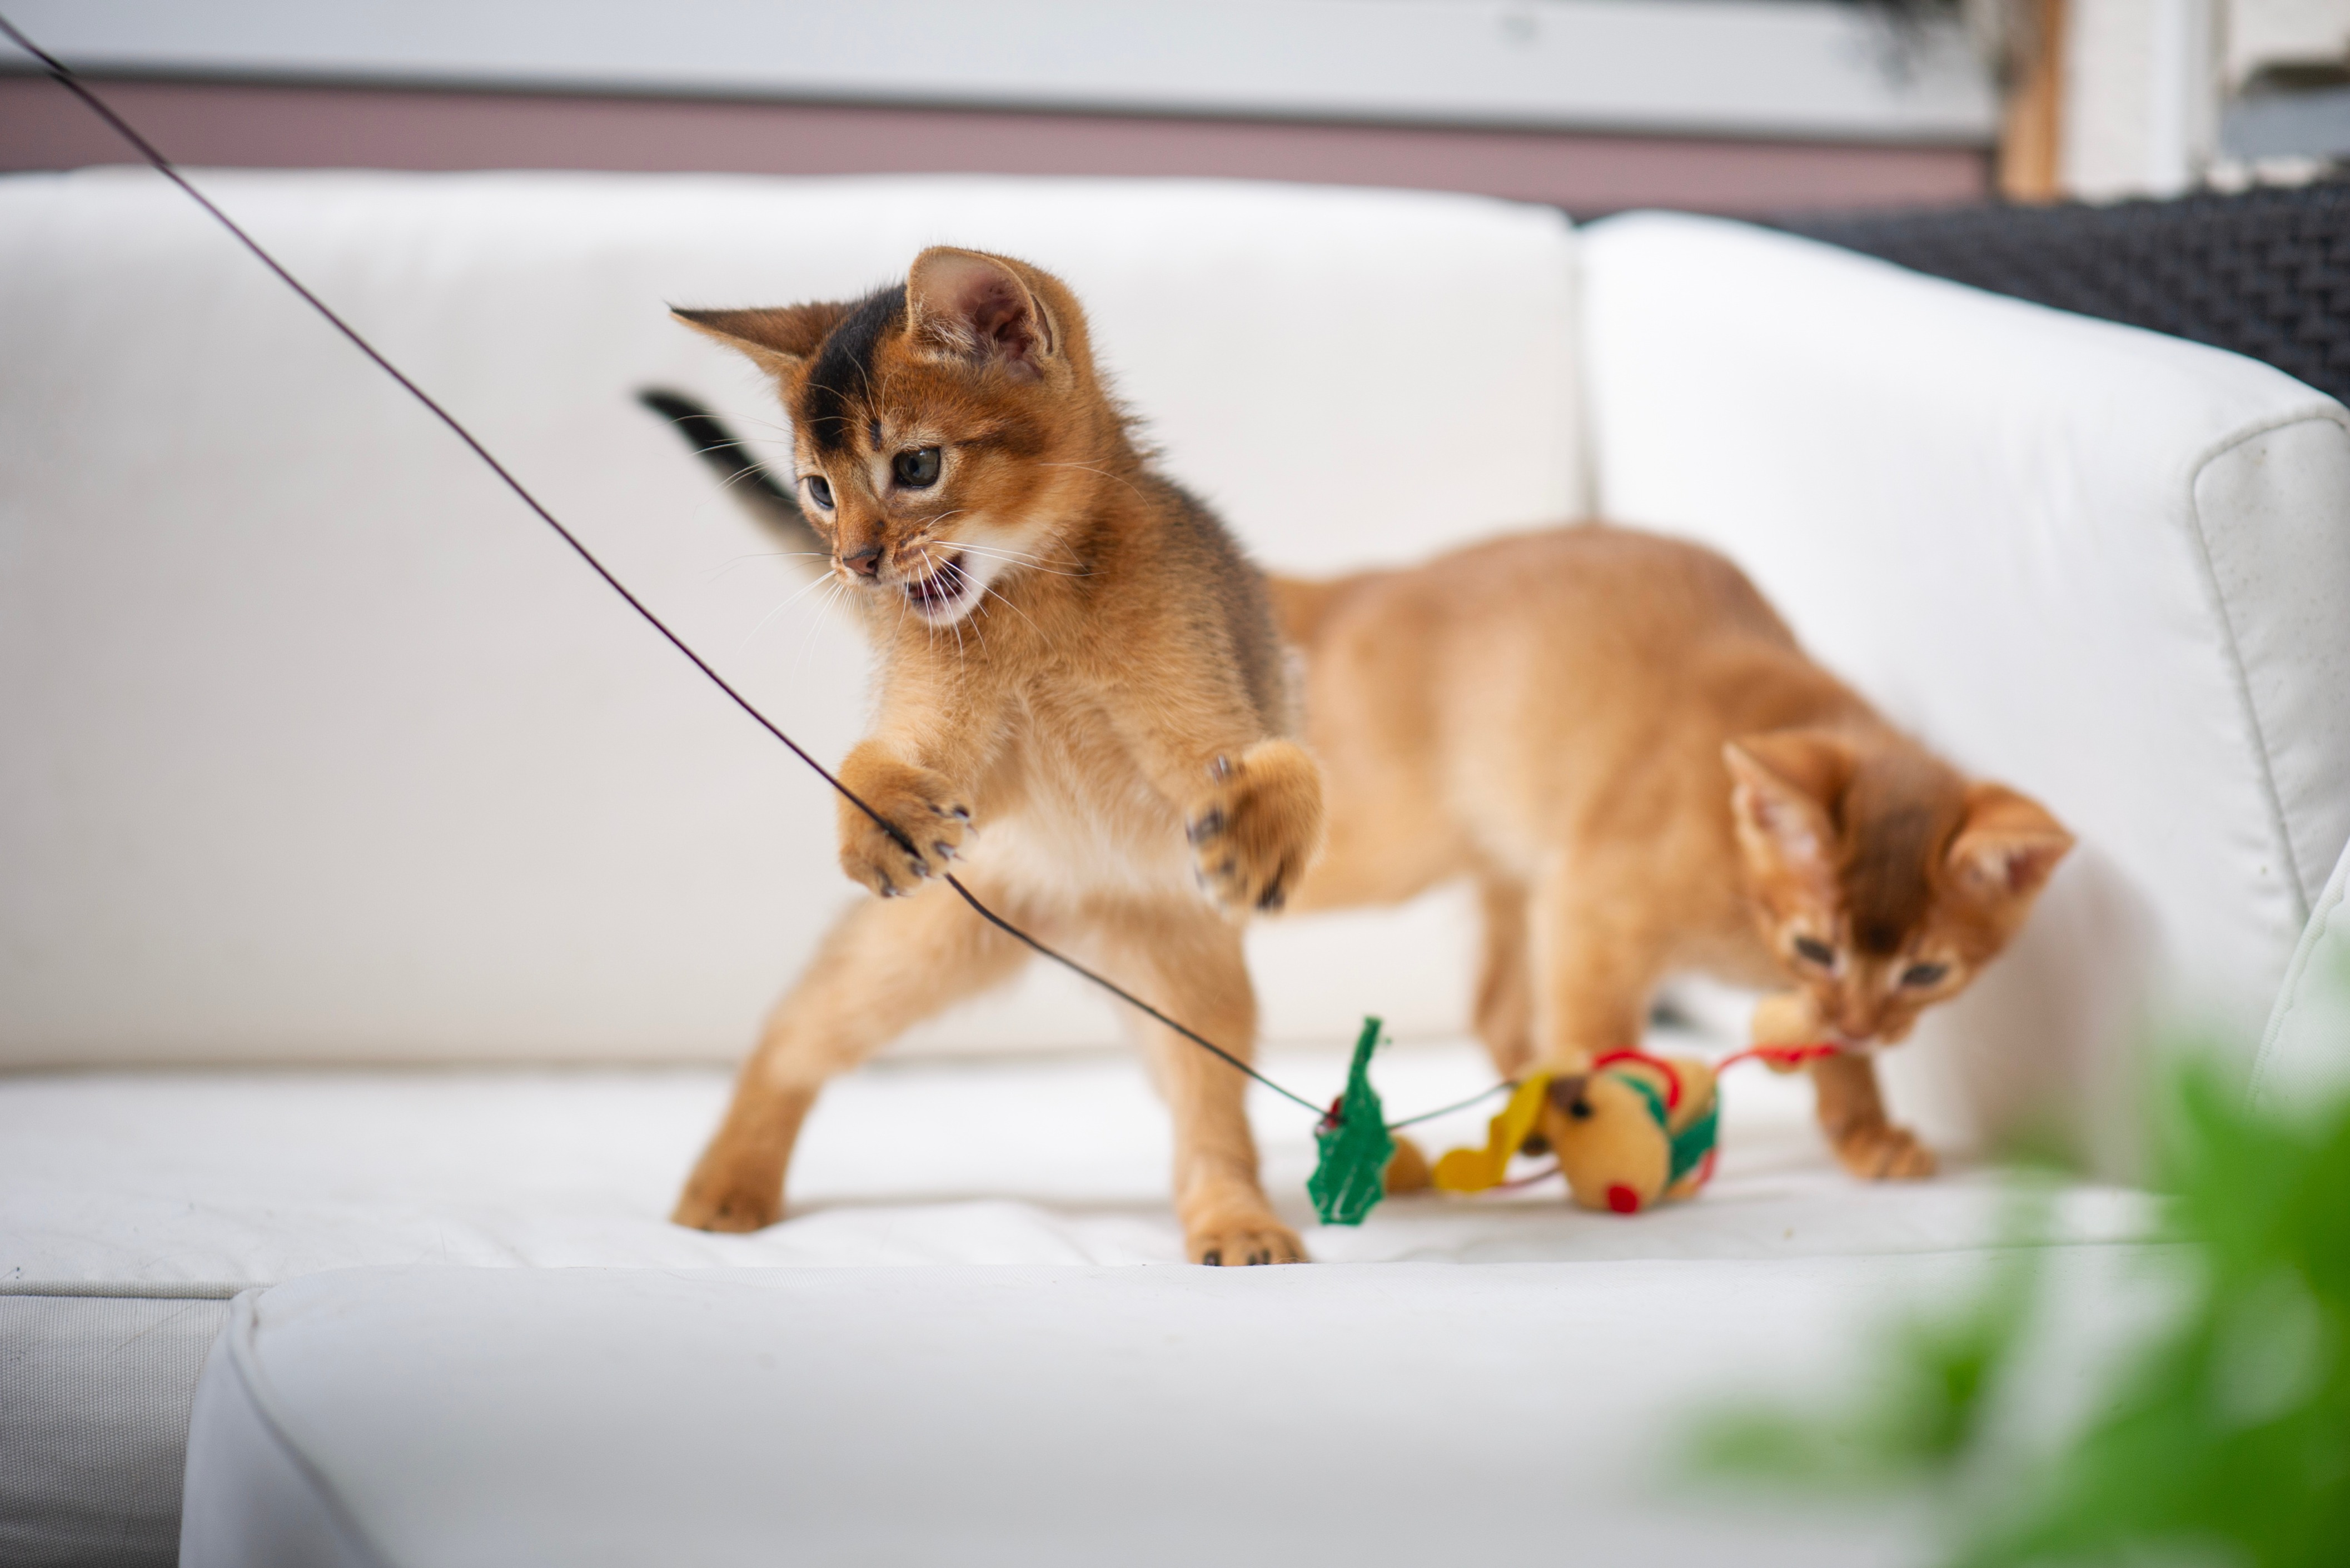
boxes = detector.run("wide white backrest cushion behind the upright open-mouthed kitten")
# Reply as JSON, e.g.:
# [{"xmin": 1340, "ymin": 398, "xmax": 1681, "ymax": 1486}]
[{"xmin": 0, "ymin": 170, "xmax": 1581, "ymax": 1065}]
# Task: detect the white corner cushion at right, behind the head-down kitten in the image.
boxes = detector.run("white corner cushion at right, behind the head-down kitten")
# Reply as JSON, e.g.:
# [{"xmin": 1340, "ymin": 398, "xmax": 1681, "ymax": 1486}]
[{"xmin": 1584, "ymin": 214, "xmax": 2350, "ymax": 1154}]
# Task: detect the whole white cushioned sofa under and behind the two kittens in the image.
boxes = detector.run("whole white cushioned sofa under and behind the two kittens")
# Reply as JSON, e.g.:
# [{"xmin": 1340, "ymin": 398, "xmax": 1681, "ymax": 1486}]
[{"xmin": 0, "ymin": 172, "xmax": 2350, "ymax": 1566}]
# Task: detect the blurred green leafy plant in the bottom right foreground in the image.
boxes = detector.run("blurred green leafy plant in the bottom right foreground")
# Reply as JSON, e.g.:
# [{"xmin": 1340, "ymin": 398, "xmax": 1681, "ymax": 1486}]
[{"xmin": 1701, "ymin": 1048, "xmax": 2350, "ymax": 1568}]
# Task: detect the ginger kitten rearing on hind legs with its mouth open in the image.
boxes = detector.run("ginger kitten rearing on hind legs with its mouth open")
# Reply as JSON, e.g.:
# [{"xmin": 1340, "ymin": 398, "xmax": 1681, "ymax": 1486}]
[{"xmin": 674, "ymin": 249, "xmax": 1323, "ymax": 1265}]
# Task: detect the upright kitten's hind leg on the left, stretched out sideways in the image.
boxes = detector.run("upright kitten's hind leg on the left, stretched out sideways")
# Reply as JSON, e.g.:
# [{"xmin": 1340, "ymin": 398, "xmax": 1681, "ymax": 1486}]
[{"xmin": 670, "ymin": 882, "xmax": 1027, "ymax": 1229}]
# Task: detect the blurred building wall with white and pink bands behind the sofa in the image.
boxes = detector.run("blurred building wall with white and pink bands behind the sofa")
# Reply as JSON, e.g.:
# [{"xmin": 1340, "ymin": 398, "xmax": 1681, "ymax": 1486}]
[{"xmin": 0, "ymin": 0, "xmax": 2350, "ymax": 216}]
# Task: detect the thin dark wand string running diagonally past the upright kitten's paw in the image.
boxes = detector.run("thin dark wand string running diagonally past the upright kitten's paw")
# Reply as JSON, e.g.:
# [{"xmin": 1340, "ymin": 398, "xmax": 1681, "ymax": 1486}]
[{"xmin": 0, "ymin": 17, "xmax": 1511, "ymax": 1152}]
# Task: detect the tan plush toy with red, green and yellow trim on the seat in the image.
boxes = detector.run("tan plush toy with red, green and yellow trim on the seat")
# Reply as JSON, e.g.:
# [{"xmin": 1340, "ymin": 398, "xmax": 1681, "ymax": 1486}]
[{"xmin": 1387, "ymin": 1051, "xmax": 1720, "ymax": 1213}]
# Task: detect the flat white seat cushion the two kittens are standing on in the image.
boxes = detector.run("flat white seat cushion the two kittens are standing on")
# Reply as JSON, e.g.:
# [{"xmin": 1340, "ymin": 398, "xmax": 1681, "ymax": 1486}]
[{"xmin": 0, "ymin": 1046, "xmax": 2148, "ymax": 1286}]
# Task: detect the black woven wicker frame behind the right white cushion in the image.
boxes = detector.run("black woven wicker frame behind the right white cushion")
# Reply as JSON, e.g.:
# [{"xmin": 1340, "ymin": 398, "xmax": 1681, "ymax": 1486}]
[{"xmin": 1776, "ymin": 181, "xmax": 2350, "ymax": 402}]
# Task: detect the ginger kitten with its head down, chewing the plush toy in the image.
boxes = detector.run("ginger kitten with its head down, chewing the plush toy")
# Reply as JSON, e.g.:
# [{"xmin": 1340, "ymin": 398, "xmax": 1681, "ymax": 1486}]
[{"xmin": 1274, "ymin": 524, "xmax": 2073, "ymax": 1178}]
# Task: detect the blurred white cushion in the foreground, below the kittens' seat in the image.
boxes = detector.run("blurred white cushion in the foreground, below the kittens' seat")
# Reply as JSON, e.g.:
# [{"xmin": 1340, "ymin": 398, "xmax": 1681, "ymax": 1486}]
[{"xmin": 181, "ymin": 1248, "xmax": 2145, "ymax": 1568}]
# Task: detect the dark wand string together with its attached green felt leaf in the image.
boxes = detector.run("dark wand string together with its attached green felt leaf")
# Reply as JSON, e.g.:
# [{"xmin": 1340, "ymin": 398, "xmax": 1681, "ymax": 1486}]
[{"xmin": 0, "ymin": 17, "xmax": 1513, "ymax": 1225}]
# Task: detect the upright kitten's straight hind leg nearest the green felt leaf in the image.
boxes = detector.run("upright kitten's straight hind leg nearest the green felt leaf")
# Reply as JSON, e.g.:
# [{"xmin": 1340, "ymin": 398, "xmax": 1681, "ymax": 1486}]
[{"xmin": 1104, "ymin": 905, "xmax": 1307, "ymax": 1267}]
